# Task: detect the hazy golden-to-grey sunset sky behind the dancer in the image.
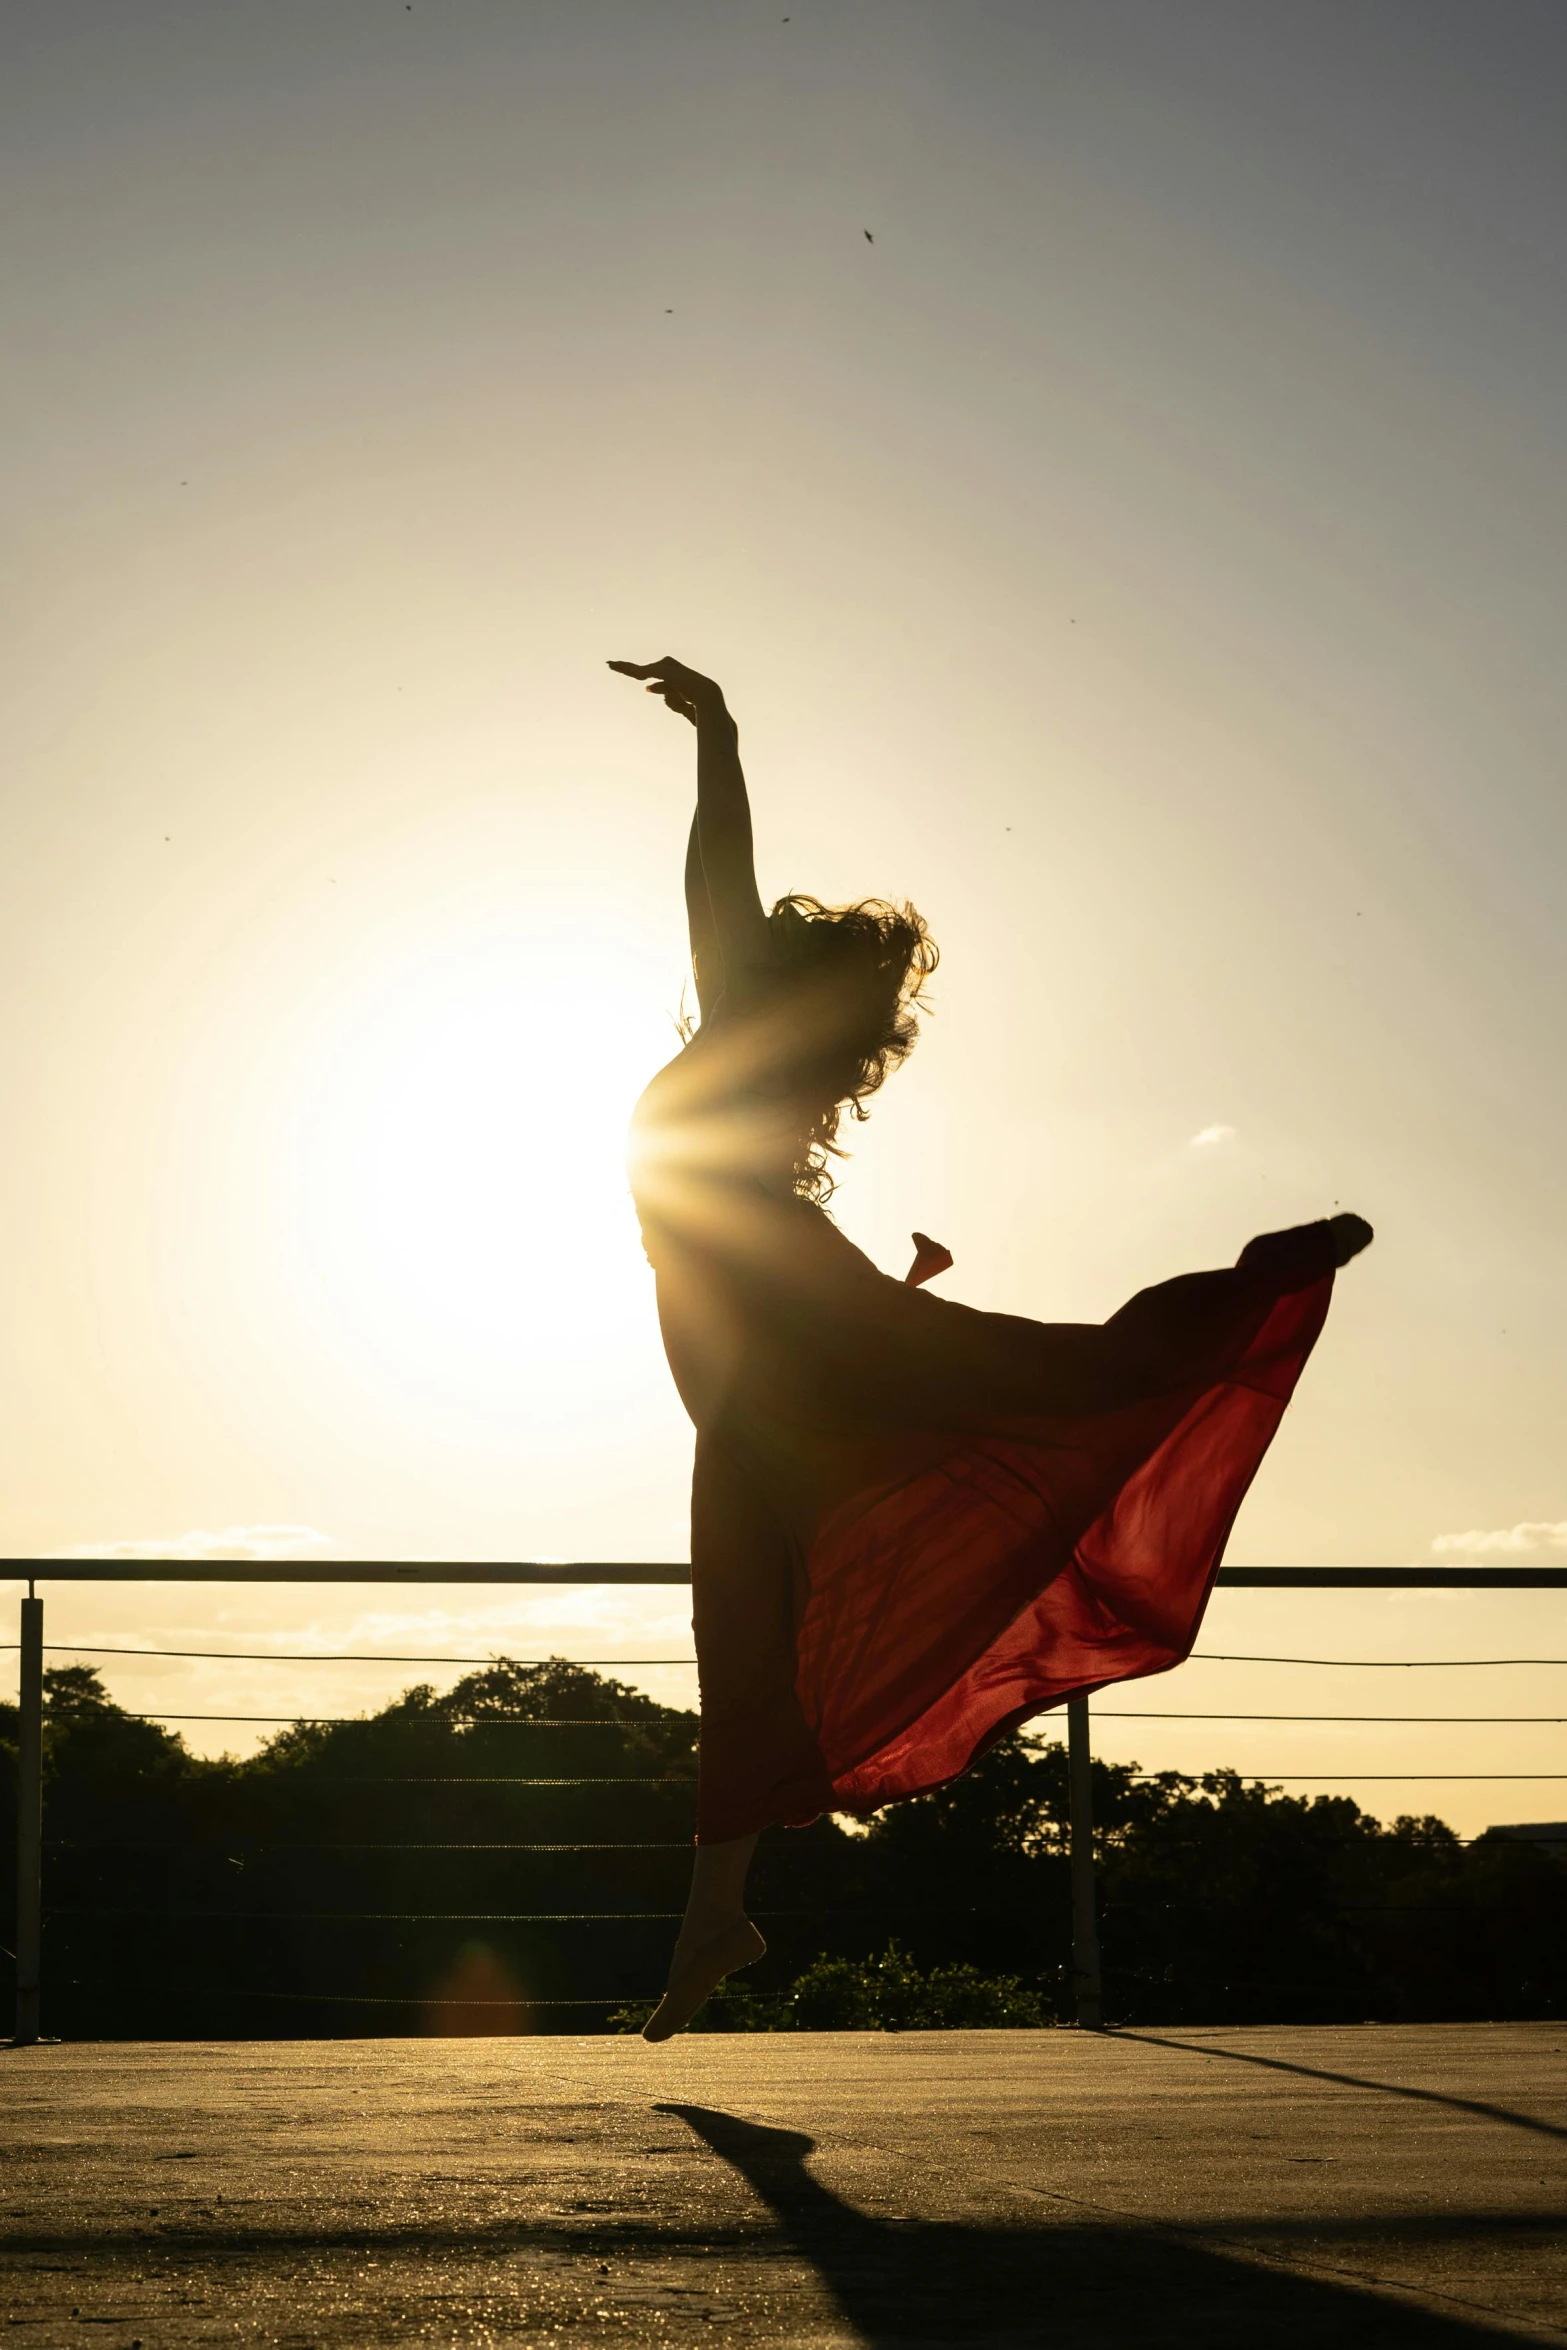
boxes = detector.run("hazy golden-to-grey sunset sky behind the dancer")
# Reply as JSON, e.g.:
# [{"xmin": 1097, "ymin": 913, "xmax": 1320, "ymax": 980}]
[{"xmin": 0, "ymin": 0, "xmax": 1567, "ymax": 1821}]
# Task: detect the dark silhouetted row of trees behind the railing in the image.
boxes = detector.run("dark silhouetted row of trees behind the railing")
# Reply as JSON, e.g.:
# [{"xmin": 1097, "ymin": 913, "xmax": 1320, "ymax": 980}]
[{"xmin": 0, "ymin": 1659, "xmax": 1567, "ymax": 2040}]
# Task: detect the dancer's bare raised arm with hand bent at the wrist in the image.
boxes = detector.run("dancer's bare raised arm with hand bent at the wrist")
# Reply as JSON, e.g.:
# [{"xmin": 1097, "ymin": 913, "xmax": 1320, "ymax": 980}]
[{"xmin": 611, "ymin": 660, "xmax": 773, "ymax": 1015}]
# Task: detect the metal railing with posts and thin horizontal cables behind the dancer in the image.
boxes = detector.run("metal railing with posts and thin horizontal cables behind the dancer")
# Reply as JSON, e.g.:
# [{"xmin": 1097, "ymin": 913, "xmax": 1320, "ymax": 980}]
[{"xmin": 0, "ymin": 1558, "xmax": 1567, "ymax": 2047}]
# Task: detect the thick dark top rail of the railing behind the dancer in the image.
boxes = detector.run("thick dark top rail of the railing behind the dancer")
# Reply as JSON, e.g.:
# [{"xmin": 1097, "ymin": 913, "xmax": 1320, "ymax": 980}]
[{"xmin": 0, "ymin": 1558, "xmax": 1567, "ymax": 1591}]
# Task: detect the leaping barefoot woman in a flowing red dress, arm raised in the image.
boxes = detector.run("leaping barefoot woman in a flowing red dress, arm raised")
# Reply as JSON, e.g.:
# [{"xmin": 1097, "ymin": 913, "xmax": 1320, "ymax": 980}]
[{"xmin": 611, "ymin": 660, "xmax": 1372, "ymax": 2040}]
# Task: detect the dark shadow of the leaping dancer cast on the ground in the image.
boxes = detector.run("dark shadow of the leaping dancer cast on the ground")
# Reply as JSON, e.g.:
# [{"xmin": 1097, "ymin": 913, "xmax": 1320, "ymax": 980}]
[{"xmin": 658, "ymin": 2106, "xmax": 1515, "ymax": 2350}]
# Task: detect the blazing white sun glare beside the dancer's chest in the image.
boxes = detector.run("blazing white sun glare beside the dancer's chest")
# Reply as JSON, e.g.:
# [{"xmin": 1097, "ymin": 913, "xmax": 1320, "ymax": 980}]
[{"xmin": 282, "ymin": 928, "xmax": 677, "ymax": 1417}]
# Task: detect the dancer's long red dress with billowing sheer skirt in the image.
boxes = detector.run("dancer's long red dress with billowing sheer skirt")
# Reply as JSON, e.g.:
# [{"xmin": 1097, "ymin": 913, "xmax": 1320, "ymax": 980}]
[{"xmin": 632, "ymin": 1018, "xmax": 1334, "ymax": 1842}]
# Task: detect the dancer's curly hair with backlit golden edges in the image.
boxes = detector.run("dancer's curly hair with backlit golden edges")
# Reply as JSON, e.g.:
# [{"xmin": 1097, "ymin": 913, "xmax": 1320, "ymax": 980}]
[{"xmin": 768, "ymin": 893, "xmax": 937, "ymax": 1206}]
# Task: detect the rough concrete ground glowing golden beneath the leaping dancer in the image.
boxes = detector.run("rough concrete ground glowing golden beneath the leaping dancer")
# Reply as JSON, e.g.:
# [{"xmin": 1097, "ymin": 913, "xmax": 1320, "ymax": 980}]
[{"xmin": 0, "ymin": 2023, "xmax": 1567, "ymax": 2350}]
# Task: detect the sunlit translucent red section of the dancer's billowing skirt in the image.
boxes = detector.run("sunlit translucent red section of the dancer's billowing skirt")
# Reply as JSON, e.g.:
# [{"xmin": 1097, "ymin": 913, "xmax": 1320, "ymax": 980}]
[{"xmin": 817, "ymin": 1278, "xmax": 1332, "ymax": 1812}]
